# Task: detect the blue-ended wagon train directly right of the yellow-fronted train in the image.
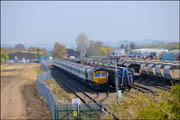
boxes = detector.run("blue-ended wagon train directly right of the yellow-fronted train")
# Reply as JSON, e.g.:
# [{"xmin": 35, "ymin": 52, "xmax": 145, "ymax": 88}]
[{"xmin": 69, "ymin": 59, "xmax": 134, "ymax": 90}]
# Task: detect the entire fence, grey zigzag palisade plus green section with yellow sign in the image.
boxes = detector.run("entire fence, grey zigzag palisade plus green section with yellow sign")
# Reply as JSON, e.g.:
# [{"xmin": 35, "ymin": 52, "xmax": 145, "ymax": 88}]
[{"xmin": 37, "ymin": 61, "xmax": 102, "ymax": 119}]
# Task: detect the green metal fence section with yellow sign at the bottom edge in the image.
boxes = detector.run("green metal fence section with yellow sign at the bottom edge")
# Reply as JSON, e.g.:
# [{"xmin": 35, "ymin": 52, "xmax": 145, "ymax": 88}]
[{"xmin": 55, "ymin": 104, "xmax": 102, "ymax": 120}]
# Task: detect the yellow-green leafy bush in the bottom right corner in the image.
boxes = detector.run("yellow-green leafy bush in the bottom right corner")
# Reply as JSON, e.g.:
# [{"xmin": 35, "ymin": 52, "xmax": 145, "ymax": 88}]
[{"xmin": 135, "ymin": 85, "xmax": 180, "ymax": 119}]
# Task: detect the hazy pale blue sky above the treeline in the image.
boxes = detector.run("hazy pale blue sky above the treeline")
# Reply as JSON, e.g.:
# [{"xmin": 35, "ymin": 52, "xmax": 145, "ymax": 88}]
[{"xmin": 1, "ymin": 1, "xmax": 179, "ymax": 48}]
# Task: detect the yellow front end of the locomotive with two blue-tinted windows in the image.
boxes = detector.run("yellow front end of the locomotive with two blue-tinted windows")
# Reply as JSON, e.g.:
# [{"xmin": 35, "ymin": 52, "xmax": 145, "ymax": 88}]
[{"xmin": 93, "ymin": 71, "xmax": 109, "ymax": 84}]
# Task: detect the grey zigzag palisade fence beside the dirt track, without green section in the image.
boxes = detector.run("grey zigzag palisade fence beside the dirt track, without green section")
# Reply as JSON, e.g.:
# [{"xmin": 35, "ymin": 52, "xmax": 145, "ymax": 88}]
[{"xmin": 37, "ymin": 62, "xmax": 56, "ymax": 119}]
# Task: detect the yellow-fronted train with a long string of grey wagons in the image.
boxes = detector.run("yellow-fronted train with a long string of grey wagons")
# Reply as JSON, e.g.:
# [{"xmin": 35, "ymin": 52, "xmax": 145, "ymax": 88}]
[{"xmin": 54, "ymin": 60, "xmax": 109, "ymax": 90}]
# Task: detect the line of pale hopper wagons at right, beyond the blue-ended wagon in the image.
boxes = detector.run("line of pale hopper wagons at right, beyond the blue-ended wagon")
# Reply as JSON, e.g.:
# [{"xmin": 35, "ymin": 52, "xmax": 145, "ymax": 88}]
[{"xmin": 81, "ymin": 59, "xmax": 180, "ymax": 82}]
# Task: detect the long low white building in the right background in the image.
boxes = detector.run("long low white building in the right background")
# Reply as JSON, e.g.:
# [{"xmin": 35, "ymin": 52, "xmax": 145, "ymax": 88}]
[{"xmin": 130, "ymin": 48, "xmax": 168, "ymax": 57}]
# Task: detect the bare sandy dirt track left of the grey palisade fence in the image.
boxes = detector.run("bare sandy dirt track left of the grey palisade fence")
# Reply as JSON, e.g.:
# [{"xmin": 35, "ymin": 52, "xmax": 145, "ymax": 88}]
[{"xmin": 1, "ymin": 64, "xmax": 51, "ymax": 119}]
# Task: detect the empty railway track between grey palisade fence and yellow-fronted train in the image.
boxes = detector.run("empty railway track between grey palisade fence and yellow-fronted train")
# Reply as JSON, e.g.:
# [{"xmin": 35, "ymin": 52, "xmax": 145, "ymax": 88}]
[{"xmin": 51, "ymin": 68, "xmax": 119, "ymax": 119}]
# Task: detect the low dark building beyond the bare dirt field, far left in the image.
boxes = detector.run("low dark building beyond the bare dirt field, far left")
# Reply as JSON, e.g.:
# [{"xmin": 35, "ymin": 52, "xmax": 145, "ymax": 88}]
[{"xmin": 8, "ymin": 52, "xmax": 36, "ymax": 62}]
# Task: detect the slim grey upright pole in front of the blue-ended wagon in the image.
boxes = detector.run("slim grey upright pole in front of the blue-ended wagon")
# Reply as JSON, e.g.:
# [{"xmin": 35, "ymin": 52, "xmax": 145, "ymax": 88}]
[{"xmin": 115, "ymin": 59, "xmax": 119, "ymax": 105}]
